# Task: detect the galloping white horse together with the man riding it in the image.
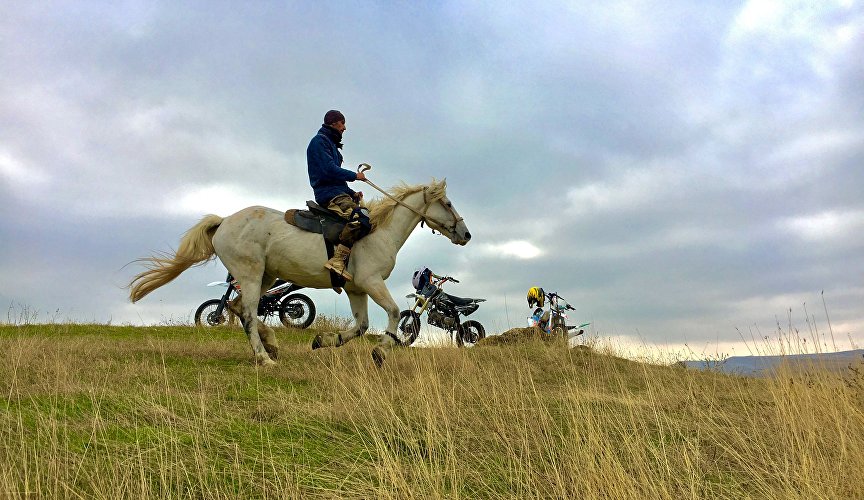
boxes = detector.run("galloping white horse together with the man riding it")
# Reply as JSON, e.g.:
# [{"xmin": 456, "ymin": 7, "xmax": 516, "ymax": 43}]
[{"xmin": 129, "ymin": 111, "xmax": 471, "ymax": 366}]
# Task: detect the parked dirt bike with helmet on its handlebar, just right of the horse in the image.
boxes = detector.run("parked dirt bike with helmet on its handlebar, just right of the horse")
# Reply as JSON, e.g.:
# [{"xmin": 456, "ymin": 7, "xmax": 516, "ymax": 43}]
[{"xmin": 396, "ymin": 276, "xmax": 486, "ymax": 347}]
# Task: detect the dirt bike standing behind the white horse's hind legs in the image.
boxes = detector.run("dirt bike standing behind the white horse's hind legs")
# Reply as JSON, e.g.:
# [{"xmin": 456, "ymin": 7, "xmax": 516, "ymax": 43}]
[{"xmin": 195, "ymin": 274, "xmax": 315, "ymax": 329}]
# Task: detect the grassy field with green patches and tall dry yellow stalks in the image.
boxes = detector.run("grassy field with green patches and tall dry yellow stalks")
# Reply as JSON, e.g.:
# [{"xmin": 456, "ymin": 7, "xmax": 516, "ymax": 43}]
[{"xmin": 0, "ymin": 324, "xmax": 864, "ymax": 499}]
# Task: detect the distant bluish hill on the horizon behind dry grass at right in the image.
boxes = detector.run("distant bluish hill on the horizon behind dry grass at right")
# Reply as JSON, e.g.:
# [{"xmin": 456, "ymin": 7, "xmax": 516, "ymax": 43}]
[{"xmin": 679, "ymin": 349, "xmax": 864, "ymax": 376}]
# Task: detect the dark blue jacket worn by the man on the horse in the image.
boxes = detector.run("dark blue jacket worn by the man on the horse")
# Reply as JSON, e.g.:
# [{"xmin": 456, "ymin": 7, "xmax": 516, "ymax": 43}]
[{"xmin": 306, "ymin": 126, "xmax": 357, "ymax": 208}]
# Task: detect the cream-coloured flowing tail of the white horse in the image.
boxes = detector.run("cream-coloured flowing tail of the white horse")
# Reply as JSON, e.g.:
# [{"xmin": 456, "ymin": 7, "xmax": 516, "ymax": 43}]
[{"xmin": 129, "ymin": 214, "xmax": 222, "ymax": 302}]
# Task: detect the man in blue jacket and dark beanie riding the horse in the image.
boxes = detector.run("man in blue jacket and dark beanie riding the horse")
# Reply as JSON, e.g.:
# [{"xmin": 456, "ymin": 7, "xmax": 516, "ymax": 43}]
[{"xmin": 306, "ymin": 109, "xmax": 372, "ymax": 281}]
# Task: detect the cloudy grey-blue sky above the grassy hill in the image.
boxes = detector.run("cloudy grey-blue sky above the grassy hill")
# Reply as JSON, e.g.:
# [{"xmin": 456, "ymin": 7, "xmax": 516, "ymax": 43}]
[{"xmin": 0, "ymin": 0, "xmax": 864, "ymax": 354}]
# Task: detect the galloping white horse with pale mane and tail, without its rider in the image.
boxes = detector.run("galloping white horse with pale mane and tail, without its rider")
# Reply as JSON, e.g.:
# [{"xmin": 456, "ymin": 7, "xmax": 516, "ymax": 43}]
[{"xmin": 129, "ymin": 179, "xmax": 471, "ymax": 366}]
